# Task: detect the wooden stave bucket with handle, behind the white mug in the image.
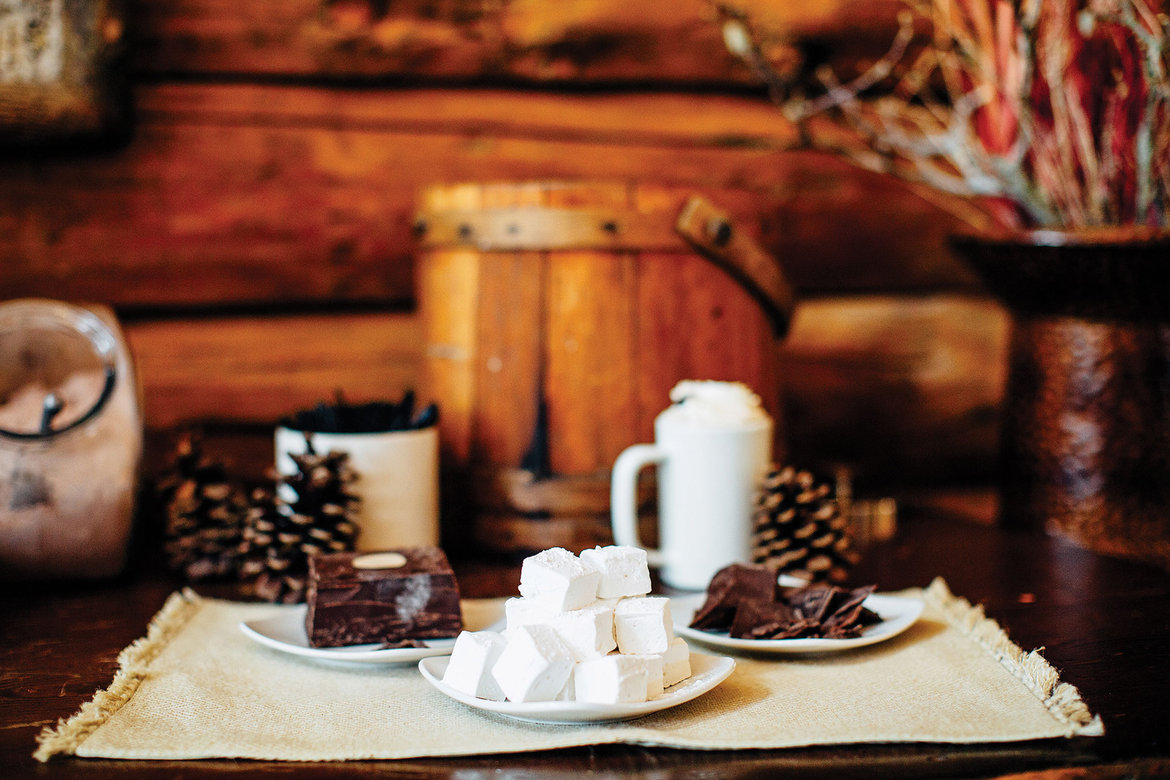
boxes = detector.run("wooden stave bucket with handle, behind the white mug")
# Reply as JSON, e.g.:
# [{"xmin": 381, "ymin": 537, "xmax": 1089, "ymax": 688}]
[{"xmin": 417, "ymin": 182, "xmax": 793, "ymax": 553}]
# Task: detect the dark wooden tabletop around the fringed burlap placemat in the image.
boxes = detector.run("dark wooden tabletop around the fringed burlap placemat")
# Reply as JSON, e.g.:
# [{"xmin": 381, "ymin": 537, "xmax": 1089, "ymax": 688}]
[{"xmin": 0, "ymin": 513, "xmax": 1170, "ymax": 779}]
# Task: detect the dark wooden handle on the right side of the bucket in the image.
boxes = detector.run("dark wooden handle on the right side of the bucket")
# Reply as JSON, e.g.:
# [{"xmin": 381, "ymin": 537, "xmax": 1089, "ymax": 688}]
[{"xmin": 675, "ymin": 195, "xmax": 797, "ymax": 339}]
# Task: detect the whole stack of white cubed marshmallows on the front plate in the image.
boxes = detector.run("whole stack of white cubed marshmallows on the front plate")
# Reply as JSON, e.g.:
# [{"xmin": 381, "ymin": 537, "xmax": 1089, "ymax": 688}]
[{"xmin": 443, "ymin": 546, "xmax": 690, "ymax": 704}]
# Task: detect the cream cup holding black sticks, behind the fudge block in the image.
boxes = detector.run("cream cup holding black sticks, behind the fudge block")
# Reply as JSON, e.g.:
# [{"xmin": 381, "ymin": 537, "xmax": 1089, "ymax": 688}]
[{"xmin": 276, "ymin": 426, "xmax": 439, "ymax": 552}]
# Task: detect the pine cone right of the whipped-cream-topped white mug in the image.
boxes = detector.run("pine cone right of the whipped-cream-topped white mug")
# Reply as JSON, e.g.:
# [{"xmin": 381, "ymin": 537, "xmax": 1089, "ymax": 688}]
[{"xmin": 752, "ymin": 467, "xmax": 858, "ymax": 582}]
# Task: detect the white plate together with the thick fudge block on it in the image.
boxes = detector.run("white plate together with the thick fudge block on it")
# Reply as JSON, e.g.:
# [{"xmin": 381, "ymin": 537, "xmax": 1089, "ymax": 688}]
[{"xmin": 240, "ymin": 547, "xmax": 487, "ymax": 663}]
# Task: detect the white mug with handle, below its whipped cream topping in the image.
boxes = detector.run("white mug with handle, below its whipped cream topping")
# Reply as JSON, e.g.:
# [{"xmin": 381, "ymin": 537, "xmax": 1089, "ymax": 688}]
[{"xmin": 610, "ymin": 381, "xmax": 772, "ymax": 589}]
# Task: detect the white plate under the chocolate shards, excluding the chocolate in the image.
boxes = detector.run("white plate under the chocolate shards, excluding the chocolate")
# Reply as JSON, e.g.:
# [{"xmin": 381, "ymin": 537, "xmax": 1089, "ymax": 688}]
[{"xmin": 670, "ymin": 578, "xmax": 922, "ymax": 654}]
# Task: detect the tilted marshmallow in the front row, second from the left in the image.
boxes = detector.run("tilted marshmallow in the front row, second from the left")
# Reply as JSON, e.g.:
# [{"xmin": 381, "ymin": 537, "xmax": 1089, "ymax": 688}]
[{"xmin": 491, "ymin": 626, "xmax": 574, "ymax": 702}]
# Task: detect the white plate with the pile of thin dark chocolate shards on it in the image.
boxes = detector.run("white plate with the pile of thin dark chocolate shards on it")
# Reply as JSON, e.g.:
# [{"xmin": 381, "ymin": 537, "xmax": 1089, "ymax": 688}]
[{"xmin": 670, "ymin": 564, "xmax": 922, "ymax": 654}]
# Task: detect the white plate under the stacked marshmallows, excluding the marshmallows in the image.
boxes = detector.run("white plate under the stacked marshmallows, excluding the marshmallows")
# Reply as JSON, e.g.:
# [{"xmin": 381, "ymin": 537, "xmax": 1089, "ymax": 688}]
[{"xmin": 419, "ymin": 653, "xmax": 735, "ymax": 723}]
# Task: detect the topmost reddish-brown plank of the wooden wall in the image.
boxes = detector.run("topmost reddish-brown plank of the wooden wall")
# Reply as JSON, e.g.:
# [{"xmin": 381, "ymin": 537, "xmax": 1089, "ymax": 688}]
[{"xmin": 135, "ymin": 0, "xmax": 899, "ymax": 85}]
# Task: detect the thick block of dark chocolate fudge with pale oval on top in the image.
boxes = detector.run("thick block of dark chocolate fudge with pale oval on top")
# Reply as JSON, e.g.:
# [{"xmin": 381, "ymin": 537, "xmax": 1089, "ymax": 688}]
[{"xmin": 305, "ymin": 547, "xmax": 463, "ymax": 647}]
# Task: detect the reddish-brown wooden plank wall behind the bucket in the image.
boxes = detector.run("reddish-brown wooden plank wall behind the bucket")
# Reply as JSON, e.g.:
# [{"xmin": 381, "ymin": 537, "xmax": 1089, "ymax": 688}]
[{"xmin": 0, "ymin": 0, "xmax": 1007, "ymax": 491}]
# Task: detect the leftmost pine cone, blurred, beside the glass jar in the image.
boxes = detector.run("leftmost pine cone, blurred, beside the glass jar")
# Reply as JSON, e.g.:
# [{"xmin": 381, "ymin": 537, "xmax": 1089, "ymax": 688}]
[{"xmin": 156, "ymin": 434, "xmax": 245, "ymax": 581}]
